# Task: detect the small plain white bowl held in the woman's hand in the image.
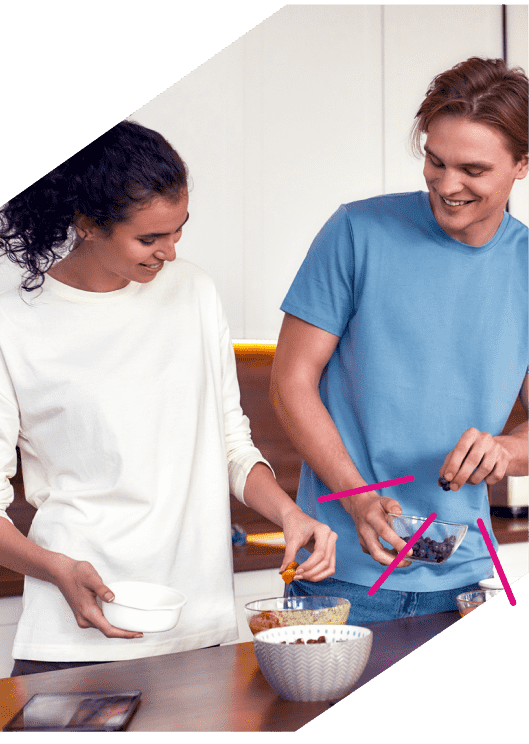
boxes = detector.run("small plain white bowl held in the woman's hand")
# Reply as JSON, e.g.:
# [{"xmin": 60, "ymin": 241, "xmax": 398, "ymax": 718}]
[{"xmin": 102, "ymin": 581, "xmax": 187, "ymax": 633}]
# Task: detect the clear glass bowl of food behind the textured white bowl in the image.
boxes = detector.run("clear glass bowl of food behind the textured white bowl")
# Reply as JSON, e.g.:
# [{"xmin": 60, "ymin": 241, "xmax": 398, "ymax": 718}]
[{"xmin": 244, "ymin": 596, "xmax": 351, "ymax": 635}]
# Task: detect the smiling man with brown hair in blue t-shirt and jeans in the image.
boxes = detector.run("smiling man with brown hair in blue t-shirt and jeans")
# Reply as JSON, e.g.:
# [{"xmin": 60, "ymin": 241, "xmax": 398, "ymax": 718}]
[{"xmin": 271, "ymin": 58, "xmax": 529, "ymax": 624}]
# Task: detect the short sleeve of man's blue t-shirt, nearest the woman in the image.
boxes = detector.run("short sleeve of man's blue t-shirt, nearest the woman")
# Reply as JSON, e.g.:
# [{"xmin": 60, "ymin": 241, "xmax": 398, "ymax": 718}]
[{"xmin": 281, "ymin": 205, "xmax": 355, "ymax": 336}]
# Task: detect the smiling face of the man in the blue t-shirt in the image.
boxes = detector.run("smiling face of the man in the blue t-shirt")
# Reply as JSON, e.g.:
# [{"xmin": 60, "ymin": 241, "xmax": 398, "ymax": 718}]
[{"xmin": 423, "ymin": 115, "xmax": 528, "ymax": 246}]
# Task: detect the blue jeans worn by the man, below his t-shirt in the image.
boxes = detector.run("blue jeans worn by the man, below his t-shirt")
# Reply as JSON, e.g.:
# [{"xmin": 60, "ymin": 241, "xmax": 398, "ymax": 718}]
[{"xmin": 289, "ymin": 578, "xmax": 479, "ymax": 625}]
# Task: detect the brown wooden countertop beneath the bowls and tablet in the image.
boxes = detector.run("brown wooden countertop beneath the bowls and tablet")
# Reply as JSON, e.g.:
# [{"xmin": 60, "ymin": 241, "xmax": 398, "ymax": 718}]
[{"xmin": 0, "ymin": 612, "xmax": 462, "ymax": 732}]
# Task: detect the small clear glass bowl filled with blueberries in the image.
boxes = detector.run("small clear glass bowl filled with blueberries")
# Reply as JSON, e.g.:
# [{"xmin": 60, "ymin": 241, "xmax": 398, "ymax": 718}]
[{"xmin": 388, "ymin": 514, "xmax": 468, "ymax": 564}]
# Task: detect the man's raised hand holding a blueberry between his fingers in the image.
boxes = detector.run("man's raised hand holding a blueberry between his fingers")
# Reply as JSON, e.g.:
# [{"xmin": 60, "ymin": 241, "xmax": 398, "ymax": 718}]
[{"xmin": 440, "ymin": 428, "xmax": 511, "ymax": 491}]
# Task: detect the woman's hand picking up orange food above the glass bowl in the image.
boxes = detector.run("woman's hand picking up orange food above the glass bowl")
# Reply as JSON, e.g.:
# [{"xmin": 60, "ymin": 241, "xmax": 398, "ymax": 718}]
[{"xmin": 279, "ymin": 507, "xmax": 338, "ymax": 581}]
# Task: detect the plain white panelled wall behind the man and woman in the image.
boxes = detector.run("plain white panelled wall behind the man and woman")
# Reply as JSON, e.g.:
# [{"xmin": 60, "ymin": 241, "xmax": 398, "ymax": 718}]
[{"xmin": 0, "ymin": 3, "xmax": 529, "ymax": 341}]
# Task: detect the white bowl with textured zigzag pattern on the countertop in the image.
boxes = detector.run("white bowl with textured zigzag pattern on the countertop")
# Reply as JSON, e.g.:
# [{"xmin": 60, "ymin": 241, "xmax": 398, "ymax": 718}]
[{"xmin": 253, "ymin": 625, "xmax": 373, "ymax": 702}]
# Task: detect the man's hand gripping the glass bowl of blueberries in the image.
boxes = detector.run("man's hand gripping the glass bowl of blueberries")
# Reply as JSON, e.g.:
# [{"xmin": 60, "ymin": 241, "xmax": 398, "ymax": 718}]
[{"xmin": 341, "ymin": 491, "xmax": 412, "ymax": 568}]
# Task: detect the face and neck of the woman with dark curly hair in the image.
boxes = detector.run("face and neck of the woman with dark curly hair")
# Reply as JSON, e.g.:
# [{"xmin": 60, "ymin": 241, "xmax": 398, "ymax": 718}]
[{"xmin": 57, "ymin": 191, "xmax": 189, "ymax": 292}]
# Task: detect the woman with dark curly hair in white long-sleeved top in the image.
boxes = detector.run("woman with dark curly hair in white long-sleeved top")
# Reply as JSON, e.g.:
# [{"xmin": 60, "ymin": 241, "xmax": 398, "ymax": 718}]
[{"xmin": 0, "ymin": 121, "xmax": 336, "ymax": 675}]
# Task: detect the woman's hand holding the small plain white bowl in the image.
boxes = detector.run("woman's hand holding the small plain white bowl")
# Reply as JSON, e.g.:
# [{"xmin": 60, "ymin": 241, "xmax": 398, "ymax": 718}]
[{"xmin": 53, "ymin": 553, "xmax": 143, "ymax": 638}]
